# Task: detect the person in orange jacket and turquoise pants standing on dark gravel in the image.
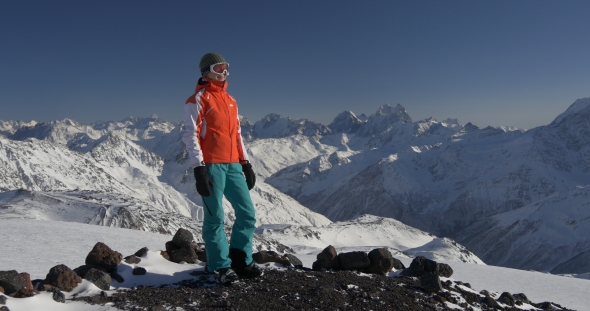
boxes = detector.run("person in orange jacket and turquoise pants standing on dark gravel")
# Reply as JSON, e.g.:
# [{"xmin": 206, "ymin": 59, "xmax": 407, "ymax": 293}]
[{"xmin": 182, "ymin": 53, "xmax": 262, "ymax": 283}]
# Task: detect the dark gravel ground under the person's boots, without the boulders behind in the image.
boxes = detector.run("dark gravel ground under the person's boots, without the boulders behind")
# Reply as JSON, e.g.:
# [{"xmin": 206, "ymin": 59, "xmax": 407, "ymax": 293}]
[{"xmin": 77, "ymin": 269, "xmax": 567, "ymax": 311}]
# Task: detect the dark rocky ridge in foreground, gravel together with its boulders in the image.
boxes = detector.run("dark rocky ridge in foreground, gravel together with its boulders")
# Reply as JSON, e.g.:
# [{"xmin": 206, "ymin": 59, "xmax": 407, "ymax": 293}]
[{"xmin": 0, "ymin": 229, "xmax": 568, "ymax": 311}]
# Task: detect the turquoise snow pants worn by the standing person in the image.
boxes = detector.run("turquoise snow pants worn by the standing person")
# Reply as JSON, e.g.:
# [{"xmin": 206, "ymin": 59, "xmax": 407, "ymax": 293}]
[{"xmin": 203, "ymin": 163, "xmax": 256, "ymax": 271}]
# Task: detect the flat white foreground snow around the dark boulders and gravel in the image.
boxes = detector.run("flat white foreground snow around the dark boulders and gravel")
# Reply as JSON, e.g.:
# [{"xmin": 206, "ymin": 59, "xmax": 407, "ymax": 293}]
[{"xmin": 0, "ymin": 219, "xmax": 590, "ymax": 311}]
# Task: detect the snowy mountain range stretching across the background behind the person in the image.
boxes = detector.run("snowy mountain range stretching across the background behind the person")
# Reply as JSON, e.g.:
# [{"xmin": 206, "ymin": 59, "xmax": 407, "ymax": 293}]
[{"xmin": 0, "ymin": 98, "xmax": 590, "ymax": 273}]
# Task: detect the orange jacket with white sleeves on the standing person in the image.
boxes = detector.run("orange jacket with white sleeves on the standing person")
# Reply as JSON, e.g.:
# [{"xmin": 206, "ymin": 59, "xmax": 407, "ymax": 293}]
[{"xmin": 182, "ymin": 78, "xmax": 248, "ymax": 166}]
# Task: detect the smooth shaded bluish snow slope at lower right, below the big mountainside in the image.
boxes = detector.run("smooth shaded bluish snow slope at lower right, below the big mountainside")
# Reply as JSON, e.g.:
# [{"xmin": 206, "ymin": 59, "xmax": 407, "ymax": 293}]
[{"xmin": 457, "ymin": 185, "xmax": 590, "ymax": 273}]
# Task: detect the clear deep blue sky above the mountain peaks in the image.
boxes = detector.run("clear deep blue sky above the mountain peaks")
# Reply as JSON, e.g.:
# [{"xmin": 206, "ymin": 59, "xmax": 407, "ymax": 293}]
[{"xmin": 0, "ymin": 0, "xmax": 590, "ymax": 128}]
